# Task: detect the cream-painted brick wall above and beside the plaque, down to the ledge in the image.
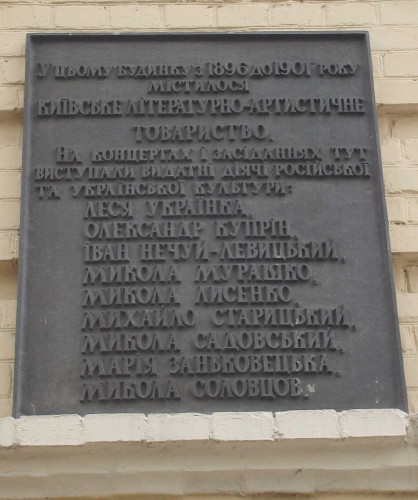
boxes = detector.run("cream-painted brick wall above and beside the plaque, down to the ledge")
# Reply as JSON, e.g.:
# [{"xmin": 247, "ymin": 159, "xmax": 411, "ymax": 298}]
[{"xmin": 0, "ymin": 0, "xmax": 418, "ymax": 416}]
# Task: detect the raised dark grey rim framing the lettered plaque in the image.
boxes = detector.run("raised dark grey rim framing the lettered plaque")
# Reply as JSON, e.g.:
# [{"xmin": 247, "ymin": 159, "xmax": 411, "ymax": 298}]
[{"xmin": 12, "ymin": 30, "xmax": 408, "ymax": 418}]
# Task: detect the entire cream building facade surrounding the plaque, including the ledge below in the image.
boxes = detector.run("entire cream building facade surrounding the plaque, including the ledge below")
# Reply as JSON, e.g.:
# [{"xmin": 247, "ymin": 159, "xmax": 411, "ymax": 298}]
[{"xmin": 0, "ymin": 0, "xmax": 418, "ymax": 500}]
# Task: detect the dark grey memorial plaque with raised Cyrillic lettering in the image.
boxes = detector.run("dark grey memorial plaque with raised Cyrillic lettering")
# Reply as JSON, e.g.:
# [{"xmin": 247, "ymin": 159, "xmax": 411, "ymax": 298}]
[{"xmin": 15, "ymin": 32, "xmax": 406, "ymax": 416}]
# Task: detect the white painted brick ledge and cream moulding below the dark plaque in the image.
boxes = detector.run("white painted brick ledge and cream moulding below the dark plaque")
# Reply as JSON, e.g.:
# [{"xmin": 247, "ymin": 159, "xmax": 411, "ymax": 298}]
[{"xmin": 0, "ymin": 410, "xmax": 418, "ymax": 500}]
